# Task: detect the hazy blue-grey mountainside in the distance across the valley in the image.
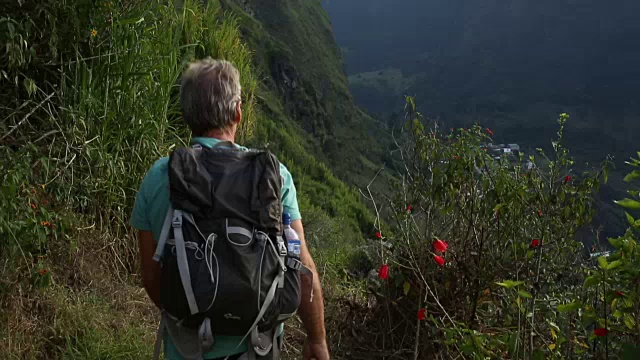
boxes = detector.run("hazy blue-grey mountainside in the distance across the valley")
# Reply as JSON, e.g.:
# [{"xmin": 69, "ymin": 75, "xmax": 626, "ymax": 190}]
[{"xmin": 323, "ymin": 0, "xmax": 640, "ymax": 240}]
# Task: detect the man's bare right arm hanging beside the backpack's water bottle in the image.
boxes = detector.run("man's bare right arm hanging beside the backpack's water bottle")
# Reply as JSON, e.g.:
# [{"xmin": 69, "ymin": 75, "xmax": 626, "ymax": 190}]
[{"xmin": 291, "ymin": 220, "xmax": 329, "ymax": 360}]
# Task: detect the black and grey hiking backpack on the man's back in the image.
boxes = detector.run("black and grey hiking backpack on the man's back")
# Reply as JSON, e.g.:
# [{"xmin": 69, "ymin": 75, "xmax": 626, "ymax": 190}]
[{"xmin": 154, "ymin": 142, "xmax": 310, "ymax": 360}]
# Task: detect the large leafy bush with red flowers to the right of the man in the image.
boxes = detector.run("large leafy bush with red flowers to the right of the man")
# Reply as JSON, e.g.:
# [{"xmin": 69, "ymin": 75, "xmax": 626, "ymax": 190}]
[{"xmin": 348, "ymin": 98, "xmax": 617, "ymax": 359}]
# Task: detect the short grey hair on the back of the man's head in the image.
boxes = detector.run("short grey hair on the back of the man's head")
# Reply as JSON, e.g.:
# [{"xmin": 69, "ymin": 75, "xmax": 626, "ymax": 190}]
[{"xmin": 180, "ymin": 58, "xmax": 242, "ymax": 135}]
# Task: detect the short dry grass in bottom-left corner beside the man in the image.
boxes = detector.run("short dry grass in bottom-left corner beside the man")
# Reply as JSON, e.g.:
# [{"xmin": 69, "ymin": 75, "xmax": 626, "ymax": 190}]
[{"xmin": 0, "ymin": 285, "xmax": 157, "ymax": 360}]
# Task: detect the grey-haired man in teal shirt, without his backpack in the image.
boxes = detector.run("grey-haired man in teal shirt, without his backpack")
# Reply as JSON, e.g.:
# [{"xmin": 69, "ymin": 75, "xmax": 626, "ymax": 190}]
[{"xmin": 131, "ymin": 59, "xmax": 329, "ymax": 360}]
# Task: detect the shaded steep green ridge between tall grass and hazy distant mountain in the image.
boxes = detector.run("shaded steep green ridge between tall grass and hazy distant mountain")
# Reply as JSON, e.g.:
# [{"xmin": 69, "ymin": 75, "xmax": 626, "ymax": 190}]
[{"xmin": 222, "ymin": 0, "xmax": 398, "ymax": 191}]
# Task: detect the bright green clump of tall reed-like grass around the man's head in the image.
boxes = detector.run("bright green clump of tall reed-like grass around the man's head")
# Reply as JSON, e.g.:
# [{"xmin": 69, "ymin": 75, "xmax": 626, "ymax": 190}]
[{"xmin": 56, "ymin": 1, "xmax": 256, "ymax": 235}]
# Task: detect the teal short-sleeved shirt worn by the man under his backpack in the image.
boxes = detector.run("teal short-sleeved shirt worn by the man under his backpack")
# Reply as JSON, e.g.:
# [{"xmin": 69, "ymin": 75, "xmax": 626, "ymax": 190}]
[{"xmin": 130, "ymin": 137, "xmax": 302, "ymax": 360}]
